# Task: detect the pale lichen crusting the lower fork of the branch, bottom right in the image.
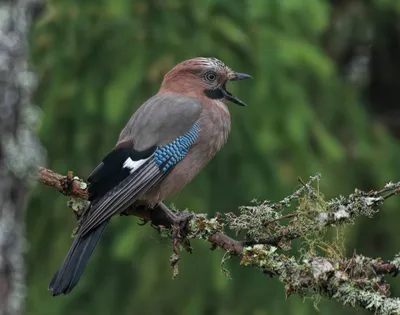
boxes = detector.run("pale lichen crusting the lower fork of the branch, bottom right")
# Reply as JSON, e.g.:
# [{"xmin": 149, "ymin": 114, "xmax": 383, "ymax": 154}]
[{"xmin": 241, "ymin": 245, "xmax": 400, "ymax": 315}]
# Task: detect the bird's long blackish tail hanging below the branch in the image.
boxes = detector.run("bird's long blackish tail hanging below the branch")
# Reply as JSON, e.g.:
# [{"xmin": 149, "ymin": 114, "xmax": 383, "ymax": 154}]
[{"xmin": 49, "ymin": 220, "xmax": 109, "ymax": 296}]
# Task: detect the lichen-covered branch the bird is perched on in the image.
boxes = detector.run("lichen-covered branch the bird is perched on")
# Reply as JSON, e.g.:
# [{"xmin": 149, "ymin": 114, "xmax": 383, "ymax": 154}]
[{"xmin": 39, "ymin": 168, "xmax": 400, "ymax": 315}]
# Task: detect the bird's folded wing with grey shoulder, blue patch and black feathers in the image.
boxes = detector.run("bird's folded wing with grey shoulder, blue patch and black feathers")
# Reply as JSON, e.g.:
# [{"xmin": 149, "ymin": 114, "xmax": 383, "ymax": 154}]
[{"xmin": 77, "ymin": 95, "xmax": 201, "ymax": 236}]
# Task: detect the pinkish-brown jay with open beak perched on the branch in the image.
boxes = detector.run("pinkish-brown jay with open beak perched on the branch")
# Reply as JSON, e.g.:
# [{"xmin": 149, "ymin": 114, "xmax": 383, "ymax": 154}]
[{"xmin": 48, "ymin": 57, "xmax": 252, "ymax": 296}]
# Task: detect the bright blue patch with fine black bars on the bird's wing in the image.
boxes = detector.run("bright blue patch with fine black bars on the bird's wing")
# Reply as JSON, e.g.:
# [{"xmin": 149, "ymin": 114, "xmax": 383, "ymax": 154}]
[{"xmin": 154, "ymin": 121, "xmax": 200, "ymax": 172}]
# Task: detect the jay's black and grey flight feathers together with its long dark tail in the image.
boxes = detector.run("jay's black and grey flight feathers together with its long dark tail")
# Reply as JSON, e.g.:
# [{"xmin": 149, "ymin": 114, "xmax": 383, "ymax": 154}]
[{"xmin": 49, "ymin": 142, "xmax": 164, "ymax": 296}]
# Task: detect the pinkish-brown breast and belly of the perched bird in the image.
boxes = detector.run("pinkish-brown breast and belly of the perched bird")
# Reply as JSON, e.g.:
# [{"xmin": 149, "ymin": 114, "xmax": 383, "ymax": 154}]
[{"xmin": 142, "ymin": 100, "xmax": 231, "ymax": 206}]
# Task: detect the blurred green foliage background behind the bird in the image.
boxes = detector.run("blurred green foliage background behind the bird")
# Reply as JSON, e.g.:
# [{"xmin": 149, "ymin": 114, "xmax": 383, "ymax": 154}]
[{"xmin": 26, "ymin": 0, "xmax": 400, "ymax": 315}]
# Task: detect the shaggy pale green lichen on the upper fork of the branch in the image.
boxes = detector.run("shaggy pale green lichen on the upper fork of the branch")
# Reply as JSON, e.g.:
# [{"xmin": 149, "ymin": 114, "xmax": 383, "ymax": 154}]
[{"xmin": 226, "ymin": 174, "xmax": 390, "ymax": 259}]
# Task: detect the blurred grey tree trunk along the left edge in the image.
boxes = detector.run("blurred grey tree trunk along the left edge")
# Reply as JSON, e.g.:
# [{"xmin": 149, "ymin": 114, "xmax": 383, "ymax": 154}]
[{"xmin": 0, "ymin": 0, "xmax": 43, "ymax": 315}]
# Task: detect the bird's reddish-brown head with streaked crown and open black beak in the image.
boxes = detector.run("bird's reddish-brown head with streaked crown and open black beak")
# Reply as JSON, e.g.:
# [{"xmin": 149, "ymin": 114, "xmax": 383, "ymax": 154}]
[{"xmin": 161, "ymin": 57, "xmax": 252, "ymax": 106}]
